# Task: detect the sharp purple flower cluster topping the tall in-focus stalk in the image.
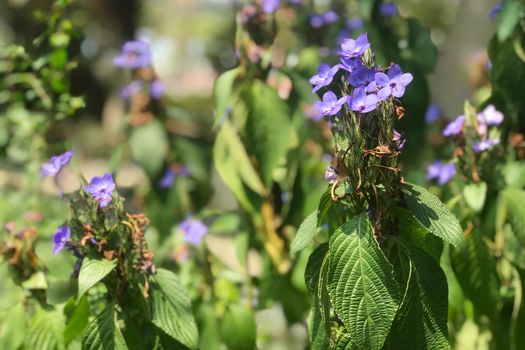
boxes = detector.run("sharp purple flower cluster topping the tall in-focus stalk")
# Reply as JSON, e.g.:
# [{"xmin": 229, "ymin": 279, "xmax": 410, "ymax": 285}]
[{"xmin": 310, "ymin": 33, "xmax": 413, "ymax": 116}]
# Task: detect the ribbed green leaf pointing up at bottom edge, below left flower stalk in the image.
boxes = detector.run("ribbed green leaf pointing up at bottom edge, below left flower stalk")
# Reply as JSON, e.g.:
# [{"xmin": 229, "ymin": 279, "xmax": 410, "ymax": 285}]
[{"xmin": 82, "ymin": 303, "xmax": 128, "ymax": 350}]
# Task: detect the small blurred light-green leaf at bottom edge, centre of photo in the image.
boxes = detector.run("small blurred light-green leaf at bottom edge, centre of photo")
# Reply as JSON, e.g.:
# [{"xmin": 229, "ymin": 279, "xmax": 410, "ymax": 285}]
[{"xmin": 222, "ymin": 304, "xmax": 256, "ymax": 350}]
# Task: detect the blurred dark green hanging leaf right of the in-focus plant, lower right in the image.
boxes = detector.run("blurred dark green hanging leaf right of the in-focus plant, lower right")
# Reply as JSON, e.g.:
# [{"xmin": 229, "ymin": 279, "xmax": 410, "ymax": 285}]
[{"xmin": 452, "ymin": 231, "xmax": 500, "ymax": 317}]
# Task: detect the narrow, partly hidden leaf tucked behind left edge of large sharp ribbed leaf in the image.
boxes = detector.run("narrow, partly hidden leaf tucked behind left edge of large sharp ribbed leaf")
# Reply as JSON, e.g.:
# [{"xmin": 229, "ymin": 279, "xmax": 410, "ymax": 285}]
[{"xmin": 304, "ymin": 243, "xmax": 330, "ymax": 350}]
